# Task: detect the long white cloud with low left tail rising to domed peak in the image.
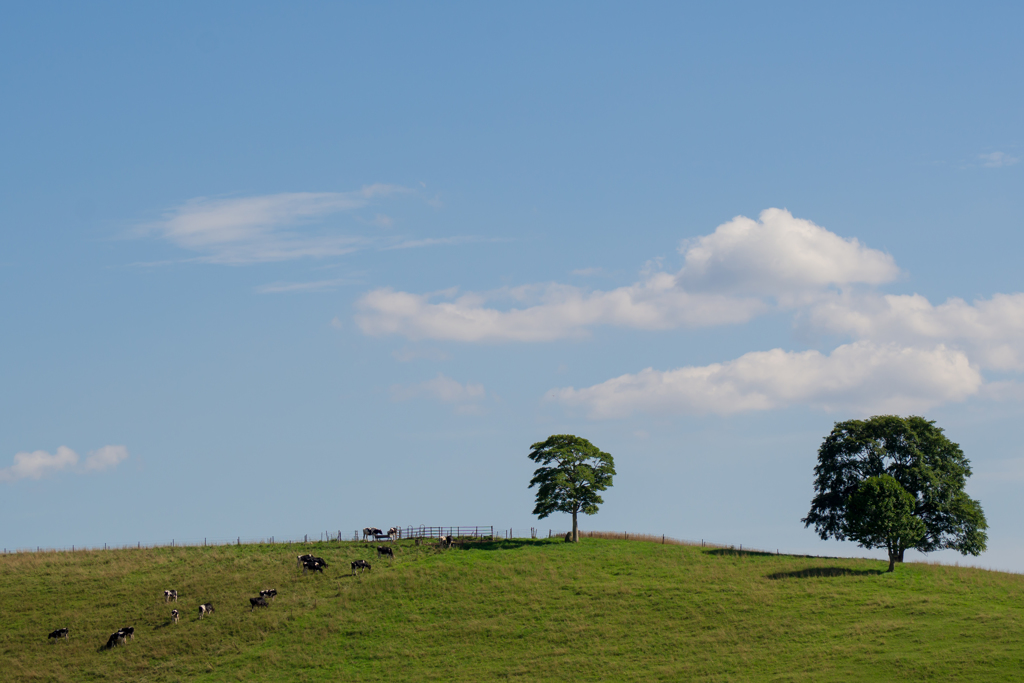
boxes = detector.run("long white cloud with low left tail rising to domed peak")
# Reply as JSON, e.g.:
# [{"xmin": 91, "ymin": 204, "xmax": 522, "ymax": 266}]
[{"xmin": 356, "ymin": 209, "xmax": 899, "ymax": 342}]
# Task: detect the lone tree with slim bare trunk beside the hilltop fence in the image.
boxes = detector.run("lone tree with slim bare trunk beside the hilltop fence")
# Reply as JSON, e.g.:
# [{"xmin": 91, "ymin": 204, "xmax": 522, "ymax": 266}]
[{"xmin": 528, "ymin": 434, "xmax": 615, "ymax": 543}]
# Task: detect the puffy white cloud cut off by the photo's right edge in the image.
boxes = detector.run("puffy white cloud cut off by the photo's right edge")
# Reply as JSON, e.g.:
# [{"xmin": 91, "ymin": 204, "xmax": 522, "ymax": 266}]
[{"xmin": 807, "ymin": 294, "xmax": 1024, "ymax": 371}]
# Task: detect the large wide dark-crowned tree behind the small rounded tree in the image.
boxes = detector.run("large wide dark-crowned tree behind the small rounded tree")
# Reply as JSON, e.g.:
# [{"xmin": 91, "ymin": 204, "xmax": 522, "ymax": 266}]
[{"xmin": 802, "ymin": 415, "xmax": 988, "ymax": 562}]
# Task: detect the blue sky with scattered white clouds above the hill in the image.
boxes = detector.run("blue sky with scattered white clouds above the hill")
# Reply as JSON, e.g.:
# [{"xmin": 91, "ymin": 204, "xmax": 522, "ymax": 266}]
[{"xmin": 6, "ymin": 3, "xmax": 1024, "ymax": 571}]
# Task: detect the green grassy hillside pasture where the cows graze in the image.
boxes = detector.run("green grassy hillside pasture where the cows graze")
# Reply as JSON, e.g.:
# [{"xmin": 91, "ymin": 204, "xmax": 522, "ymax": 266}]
[{"xmin": 0, "ymin": 539, "xmax": 1024, "ymax": 681}]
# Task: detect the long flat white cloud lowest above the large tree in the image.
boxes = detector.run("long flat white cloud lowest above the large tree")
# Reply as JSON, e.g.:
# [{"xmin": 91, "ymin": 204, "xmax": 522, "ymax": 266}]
[{"xmin": 547, "ymin": 342, "xmax": 982, "ymax": 419}]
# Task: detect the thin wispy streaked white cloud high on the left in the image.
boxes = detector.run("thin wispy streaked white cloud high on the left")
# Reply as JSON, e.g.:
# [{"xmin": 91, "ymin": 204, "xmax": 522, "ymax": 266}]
[{"xmin": 143, "ymin": 184, "xmax": 408, "ymax": 264}]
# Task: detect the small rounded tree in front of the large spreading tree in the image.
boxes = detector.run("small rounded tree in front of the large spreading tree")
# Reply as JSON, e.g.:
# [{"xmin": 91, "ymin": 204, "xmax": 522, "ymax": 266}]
[{"xmin": 846, "ymin": 474, "xmax": 927, "ymax": 571}]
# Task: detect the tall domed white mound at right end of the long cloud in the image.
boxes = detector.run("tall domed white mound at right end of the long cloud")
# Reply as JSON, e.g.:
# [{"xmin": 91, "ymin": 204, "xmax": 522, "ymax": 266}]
[{"xmin": 679, "ymin": 209, "xmax": 899, "ymax": 297}]
